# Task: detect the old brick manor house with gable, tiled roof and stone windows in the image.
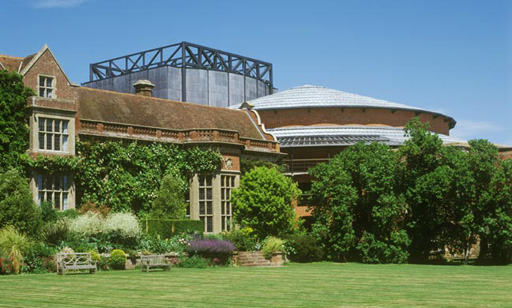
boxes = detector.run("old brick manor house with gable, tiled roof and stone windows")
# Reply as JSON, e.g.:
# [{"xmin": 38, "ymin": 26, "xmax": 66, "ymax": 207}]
[{"xmin": 0, "ymin": 45, "xmax": 283, "ymax": 233}]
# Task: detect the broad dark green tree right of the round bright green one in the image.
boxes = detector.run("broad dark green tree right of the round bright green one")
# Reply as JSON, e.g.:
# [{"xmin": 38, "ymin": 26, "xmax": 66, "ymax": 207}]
[{"xmin": 311, "ymin": 143, "xmax": 409, "ymax": 263}]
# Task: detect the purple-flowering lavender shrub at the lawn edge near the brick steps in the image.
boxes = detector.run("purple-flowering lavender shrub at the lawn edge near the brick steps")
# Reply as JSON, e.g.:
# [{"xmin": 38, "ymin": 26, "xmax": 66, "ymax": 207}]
[{"xmin": 187, "ymin": 239, "xmax": 235, "ymax": 265}]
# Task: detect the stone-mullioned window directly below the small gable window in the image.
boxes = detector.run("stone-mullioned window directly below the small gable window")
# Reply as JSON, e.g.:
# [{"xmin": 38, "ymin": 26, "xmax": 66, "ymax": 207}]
[{"xmin": 35, "ymin": 114, "xmax": 72, "ymax": 153}]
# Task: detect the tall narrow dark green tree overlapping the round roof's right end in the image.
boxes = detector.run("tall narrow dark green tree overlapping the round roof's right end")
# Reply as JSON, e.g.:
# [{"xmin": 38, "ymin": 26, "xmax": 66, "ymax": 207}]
[{"xmin": 399, "ymin": 118, "xmax": 446, "ymax": 261}]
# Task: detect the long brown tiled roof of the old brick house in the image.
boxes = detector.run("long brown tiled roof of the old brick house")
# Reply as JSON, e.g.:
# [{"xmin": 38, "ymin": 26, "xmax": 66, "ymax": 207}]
[{"xmin": 77, "ymin": 87, "xmax": 274, "ymax": 141}]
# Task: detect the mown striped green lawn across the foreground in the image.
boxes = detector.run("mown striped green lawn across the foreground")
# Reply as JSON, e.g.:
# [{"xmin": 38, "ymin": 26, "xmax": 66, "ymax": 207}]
[{"xmin": 0, "ymin": 263, "xmax": 512, "ymax": 307}]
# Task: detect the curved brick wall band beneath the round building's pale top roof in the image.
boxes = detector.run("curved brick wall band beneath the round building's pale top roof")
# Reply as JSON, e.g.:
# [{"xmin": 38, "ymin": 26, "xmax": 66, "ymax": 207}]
[{"xmin": 258, "ymin": 108, "xmax": 450, "ymax": 135}]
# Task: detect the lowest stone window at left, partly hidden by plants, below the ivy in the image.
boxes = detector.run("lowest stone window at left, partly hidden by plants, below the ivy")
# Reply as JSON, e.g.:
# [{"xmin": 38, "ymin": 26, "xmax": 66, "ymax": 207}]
[{"xmin": 34, "ymin": 172, "xmax": 74, "ymax": 211}]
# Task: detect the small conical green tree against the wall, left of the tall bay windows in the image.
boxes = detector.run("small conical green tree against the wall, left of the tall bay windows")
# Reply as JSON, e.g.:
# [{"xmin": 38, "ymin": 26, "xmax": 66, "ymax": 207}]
[{"xmin": 150, "ymin": 174, "xmax": 187, "ymax": 219}]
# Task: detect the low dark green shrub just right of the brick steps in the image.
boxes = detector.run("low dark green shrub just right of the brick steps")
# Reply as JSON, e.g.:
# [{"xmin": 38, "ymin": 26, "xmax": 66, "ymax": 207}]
[{"xmin": 285, "ymin": 235, "xmax": 323, "ymax": 262}]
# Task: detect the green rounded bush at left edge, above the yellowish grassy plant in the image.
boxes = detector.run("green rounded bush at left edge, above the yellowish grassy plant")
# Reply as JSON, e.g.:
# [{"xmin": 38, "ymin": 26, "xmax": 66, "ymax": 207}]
[{"xmin": 0, "ymin": 169, "xmax": 41, "ymax": 235}]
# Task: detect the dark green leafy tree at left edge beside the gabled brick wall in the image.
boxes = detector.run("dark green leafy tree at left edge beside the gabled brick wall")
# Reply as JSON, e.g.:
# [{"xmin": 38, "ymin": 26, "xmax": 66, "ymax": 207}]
[{"xmin": 0, "ymin": 69, "xmax": 34, "ymax": 172}]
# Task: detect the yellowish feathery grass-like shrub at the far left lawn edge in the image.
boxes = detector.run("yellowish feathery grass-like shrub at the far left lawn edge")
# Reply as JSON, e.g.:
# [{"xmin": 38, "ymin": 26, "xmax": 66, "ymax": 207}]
[{"xmin": 0, "ymin": 226, "xmax": 30, "ymax": 274}]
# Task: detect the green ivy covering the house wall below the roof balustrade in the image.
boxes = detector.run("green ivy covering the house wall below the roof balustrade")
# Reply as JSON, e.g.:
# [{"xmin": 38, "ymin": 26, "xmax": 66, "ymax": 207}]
[{"xmin": 74, "ymin": 141, "xmax": 222, "ymax": 214}]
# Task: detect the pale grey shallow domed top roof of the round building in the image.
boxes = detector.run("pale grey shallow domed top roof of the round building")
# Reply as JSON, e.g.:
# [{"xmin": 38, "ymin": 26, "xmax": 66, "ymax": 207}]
[{"xmin": 241, "ymin": 85, "xmax": 455, "ymax": 122}]
